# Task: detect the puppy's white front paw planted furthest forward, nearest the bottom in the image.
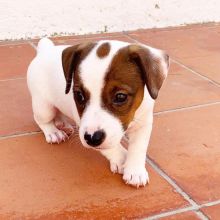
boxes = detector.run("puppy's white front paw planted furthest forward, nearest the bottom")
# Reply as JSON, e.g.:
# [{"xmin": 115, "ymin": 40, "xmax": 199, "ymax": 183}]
[{"xmin": 123, "ymin": 166, "xmax": 149, "ymax": 187}]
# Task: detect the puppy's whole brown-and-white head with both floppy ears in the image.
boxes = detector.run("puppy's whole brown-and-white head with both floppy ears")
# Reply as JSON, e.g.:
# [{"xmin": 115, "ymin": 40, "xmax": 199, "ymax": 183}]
[{"xmin": 62, "ymin": 41, "xmax": 169, "ymax": 149}]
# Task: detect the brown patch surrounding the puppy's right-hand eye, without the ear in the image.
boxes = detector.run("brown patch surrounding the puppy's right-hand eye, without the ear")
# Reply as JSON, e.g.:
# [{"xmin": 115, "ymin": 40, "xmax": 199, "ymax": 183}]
[{"xmin": 102, "ymin": 47, "xmax": 144, "ymax": 130}]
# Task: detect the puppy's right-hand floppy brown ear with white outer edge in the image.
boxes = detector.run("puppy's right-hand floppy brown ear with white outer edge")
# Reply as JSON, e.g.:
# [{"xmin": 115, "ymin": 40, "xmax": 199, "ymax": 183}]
[{"xmin": 129, "ymin": 45, "xmax": 169, "ymax": 99}]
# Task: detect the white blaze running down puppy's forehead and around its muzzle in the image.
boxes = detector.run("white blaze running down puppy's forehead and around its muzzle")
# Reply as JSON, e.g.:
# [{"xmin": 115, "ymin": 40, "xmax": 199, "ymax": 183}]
[{"xmin": 79, "ymin": 41, "xmax": 128, "ymax": 147}]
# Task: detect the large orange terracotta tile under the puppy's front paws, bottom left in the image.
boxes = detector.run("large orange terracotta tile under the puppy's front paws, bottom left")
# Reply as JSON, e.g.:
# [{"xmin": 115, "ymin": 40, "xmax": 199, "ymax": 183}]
[{"xmin": 0, "ymin": 134, "xmax": 188, "ymax": 219}]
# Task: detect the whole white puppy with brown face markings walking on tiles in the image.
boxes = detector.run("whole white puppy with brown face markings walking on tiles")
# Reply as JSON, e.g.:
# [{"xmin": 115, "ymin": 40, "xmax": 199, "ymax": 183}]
[{"xmin": 27, "ymin": 38, "xmax": 169, "ymax": 187}]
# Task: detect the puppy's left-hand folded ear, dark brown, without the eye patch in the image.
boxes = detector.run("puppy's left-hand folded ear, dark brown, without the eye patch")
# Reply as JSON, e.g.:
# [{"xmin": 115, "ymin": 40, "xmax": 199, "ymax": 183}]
[{"xmin": 62, "ymin": 42, "xmax": 95, "ymax": 94}]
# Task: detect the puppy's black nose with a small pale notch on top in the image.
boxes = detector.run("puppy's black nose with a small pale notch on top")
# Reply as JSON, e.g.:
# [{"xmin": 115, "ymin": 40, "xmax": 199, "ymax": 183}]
[{"xmin": 84, "ymin": 130, "xmax": 105, "ymax": 147}]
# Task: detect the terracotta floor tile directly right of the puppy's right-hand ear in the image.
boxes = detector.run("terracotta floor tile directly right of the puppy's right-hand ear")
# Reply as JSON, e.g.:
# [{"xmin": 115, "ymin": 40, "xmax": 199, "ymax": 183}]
[{"xmin": 155, "ymin": 62, "xmax": 220, "ymax": 112}]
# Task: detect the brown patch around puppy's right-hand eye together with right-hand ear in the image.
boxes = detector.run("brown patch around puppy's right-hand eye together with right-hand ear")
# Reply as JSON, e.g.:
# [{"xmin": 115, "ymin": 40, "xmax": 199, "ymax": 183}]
[{"xmin": 102, "ymin": 45, "xmax": 169, "ymax": 130}]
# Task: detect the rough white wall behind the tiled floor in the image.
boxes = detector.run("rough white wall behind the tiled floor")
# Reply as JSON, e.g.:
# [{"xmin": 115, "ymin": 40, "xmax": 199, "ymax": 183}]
[{"xmin": 0, "ymin": 0, "xmax": 220, "ymax": 40}]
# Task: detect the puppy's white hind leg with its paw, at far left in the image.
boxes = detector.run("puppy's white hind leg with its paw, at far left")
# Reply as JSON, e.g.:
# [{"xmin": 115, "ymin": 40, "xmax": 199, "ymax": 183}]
[{"xmin": 32, "ymin": 98, "xmax": 68, "ymax": 144}]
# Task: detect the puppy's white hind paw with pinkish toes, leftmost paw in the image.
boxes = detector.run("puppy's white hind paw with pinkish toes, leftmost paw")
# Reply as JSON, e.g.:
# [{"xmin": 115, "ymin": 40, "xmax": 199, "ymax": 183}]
[{"xmin": 44, "ymin": 129, "xmax": 68, "ymax": 144}]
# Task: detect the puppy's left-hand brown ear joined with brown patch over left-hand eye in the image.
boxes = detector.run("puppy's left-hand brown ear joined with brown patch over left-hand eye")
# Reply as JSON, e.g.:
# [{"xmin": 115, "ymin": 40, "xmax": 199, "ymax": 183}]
[{"xmin": 62, "ymin": 43, "xmax": 96, "ymax": 117}]
